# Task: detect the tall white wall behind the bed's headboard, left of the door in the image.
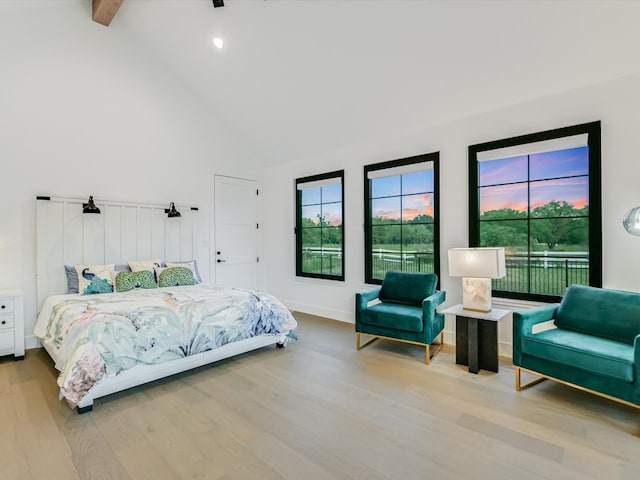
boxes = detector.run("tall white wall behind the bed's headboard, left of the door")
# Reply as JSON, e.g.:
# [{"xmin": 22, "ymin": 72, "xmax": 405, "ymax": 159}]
[{"xmin": 0, "ymin": 2, "xmax": 262, "ymax": 347}]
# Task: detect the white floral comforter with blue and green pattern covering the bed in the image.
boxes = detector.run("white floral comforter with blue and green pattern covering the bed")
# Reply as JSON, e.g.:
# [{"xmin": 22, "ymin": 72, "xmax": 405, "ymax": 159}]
[{"xmin": 33, "ymin": 284, "xmax": 296, "ymax": 407}]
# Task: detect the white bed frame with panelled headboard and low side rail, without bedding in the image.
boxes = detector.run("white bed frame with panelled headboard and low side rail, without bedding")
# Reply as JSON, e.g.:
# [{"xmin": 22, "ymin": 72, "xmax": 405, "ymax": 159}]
[{"xmin": 37, "ymin": 196, "xmax": 288, "ymax": 413}]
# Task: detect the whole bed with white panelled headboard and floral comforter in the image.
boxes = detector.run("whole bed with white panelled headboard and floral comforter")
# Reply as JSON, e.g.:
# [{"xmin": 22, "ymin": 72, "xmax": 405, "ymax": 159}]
[{"xmin": 33, "ymin": 197, "xmax": 296, "ymax": 413}]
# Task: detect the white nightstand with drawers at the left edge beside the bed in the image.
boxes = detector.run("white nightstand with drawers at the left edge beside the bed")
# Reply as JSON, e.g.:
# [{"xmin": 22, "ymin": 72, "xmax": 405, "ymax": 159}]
[{"xmin": 0, "ymin": 290, "xmax": 24, "ymax": 360}]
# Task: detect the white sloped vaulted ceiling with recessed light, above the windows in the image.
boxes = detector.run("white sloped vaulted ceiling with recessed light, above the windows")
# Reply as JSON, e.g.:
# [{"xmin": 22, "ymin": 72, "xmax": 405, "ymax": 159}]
[{"xmin": 92, "ymin": 0, "xmax": 640, "ymax": 162}]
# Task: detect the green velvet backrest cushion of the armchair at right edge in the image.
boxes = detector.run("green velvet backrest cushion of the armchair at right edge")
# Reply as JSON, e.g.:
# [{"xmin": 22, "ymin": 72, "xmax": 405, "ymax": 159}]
[{"xmin": 555, "ymin": 285, "xmax": 640, "ymax": 345}]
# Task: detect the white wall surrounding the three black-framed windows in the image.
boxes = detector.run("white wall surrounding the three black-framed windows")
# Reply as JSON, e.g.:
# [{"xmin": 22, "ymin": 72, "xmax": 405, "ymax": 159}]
[{"xmin": 263, "ymin": 72, "xmax": 640, "ymax": 354}]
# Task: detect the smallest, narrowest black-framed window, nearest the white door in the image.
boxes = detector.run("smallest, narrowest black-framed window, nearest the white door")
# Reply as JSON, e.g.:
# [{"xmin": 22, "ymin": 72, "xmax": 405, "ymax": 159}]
[{"xmin": 296, "ymin": 170, "xmax": 344, "ymax": 280}]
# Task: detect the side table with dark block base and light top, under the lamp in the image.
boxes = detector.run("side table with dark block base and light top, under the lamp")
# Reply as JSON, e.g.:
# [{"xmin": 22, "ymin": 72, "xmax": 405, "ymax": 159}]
[{"xmin": 439, "ymin": 305, "xmax": 510, "ymax": 373}]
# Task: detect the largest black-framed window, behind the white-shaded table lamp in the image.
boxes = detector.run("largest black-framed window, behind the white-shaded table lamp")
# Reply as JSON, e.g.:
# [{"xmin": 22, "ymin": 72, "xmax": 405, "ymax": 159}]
[{"xmin": 469, "ymin": 122, "xmax": 602, "ymax": 301}]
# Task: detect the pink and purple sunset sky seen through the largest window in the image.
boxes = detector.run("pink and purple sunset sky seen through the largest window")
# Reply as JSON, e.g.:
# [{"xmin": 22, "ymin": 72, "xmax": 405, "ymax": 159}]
[{"xmin": 478, "ymin": 146, "xmax": 589, "ymax": 212}]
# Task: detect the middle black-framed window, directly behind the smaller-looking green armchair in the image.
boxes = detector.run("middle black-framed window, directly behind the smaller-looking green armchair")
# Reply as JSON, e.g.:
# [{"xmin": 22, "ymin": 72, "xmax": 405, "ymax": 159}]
[{"xmin": 364, "ymin": 152, "xmax": 440, "ymax": 284}]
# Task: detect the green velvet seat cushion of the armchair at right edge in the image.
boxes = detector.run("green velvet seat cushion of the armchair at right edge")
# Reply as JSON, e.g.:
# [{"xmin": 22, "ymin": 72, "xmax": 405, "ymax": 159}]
[{"xmin": 522, "ymin": 328, "xmax": 634, "ymax": 382}]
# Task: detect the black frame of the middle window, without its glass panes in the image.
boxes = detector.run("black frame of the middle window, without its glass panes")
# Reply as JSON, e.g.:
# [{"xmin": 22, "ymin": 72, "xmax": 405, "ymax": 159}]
[{"xmin": 364, "ymin": 152, "xmax": 440, "ymax": 288}]
